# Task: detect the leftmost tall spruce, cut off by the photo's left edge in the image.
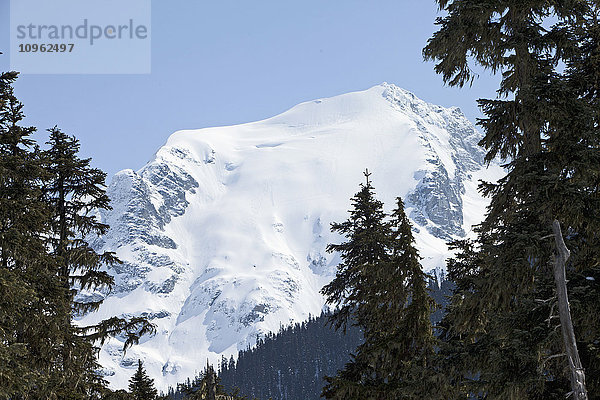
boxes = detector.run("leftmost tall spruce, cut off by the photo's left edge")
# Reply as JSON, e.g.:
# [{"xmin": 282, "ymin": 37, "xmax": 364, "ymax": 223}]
[{"xmin": 0, "ymin": 72, "xmax": 56, "ymax": 397}]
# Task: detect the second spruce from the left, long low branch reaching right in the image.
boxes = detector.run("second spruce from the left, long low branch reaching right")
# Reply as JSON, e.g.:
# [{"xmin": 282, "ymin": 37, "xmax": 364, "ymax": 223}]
[{"xmin": 43, "ymin": 127, "xmax": 153, "ymax": 398}]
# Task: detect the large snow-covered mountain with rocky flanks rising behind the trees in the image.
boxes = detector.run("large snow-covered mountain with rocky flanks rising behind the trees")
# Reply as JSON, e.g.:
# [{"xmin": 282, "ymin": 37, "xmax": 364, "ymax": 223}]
[{"xmin": 82, "ymin": 84, "xmax": 501, "ymax": 389}]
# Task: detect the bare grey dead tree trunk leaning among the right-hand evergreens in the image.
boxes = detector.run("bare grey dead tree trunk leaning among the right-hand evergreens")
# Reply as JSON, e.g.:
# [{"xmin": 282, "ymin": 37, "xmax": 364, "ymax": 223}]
[{"xmin": 552, "ymin": 220, "xmax": 588, "ymax": 400}]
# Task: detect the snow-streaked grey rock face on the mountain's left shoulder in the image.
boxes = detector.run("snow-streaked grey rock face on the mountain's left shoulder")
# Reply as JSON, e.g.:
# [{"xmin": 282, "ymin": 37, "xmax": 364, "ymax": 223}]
[{"xmin": 88, "ymin": 155, "xmax": 199, "ymax": 295}]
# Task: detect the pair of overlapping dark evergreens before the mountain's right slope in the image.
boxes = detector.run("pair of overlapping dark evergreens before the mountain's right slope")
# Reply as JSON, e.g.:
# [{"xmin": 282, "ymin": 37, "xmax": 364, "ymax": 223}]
[{"xmin": 323, "ymin": 173, "xmax": 435, "ymax": 399}]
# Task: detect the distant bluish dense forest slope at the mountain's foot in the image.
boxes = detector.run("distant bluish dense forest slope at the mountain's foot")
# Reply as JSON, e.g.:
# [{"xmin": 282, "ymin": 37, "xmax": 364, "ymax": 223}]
[{"xmin": 162, "ymin": 280, "xmax": 452, "ymax": 400}]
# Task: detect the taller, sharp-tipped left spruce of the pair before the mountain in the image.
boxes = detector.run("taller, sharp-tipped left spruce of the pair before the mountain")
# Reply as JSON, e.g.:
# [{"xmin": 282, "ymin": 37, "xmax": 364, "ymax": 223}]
[{"xmin": 321, "ymin": 171, "xmax": 391, "ymax": 399}]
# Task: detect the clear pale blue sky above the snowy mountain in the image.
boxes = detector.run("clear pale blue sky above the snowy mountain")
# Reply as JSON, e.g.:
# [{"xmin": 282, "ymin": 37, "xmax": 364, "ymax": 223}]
[{"xmin": 0, "ymin": 0, "xmax": 497, "ymax": 176}]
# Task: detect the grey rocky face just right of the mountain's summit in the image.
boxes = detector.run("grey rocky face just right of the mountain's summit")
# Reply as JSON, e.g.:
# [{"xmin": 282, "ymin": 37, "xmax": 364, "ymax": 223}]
[{"xmin": 383, "ymin": 86, "xmax": 485, "ymax": 240}]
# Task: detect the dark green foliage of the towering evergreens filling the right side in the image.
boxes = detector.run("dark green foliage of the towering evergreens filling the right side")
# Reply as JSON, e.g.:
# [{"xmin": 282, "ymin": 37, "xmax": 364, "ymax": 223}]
[{"xmin": 424, "ymin": 0, "xmax": 600, "ymax": 399}]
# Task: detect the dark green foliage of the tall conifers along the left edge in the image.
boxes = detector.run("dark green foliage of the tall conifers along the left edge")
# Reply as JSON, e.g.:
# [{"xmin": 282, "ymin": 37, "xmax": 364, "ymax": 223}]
[{"xmin": 0, "ymin": 73, "xmax": 153, "ymax": 400}]
